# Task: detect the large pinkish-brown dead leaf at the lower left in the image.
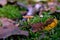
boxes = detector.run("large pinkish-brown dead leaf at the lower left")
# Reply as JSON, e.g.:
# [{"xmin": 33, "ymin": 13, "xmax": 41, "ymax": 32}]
[{"xmin": 0, "ymin": 18, "xmax": 29, "ymax": 39}]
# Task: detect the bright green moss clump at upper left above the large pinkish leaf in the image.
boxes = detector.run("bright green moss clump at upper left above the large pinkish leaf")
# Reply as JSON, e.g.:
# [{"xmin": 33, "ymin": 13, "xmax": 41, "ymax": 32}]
[{"xmin": 0, "ymin": 5, "xmax": 22, "ymax": 19}]
